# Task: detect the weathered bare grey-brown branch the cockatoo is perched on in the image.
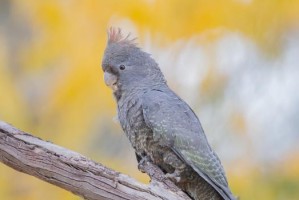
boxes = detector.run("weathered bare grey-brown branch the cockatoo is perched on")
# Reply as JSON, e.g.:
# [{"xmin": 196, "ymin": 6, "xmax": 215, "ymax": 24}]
[{"xmin": 0, "ymin": 121, "xmax": 190, "ymax": 200}]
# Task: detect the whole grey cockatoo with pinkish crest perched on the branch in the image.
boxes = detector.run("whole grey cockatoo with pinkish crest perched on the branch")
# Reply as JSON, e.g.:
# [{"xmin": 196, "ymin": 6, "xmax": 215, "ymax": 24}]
[{"xmin": 102, "ymin": 28, "xmax": 235, "ymax": 200}]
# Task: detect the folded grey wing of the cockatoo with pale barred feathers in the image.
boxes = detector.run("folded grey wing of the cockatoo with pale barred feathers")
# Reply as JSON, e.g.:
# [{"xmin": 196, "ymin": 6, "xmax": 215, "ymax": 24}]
[{"xmin": 142, "ymin": 90, "xmax": 234, "ymax": 199}]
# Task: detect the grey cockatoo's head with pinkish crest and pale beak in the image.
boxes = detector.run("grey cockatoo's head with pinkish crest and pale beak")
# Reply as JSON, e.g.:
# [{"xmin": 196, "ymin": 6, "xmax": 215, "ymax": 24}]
[{"xmin": 102, "ymin": 28, "xmax": 165, "ymax": 99}]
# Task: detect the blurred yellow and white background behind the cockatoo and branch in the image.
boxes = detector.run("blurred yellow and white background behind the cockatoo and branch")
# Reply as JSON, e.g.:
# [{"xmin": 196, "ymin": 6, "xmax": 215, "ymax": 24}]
[{"xmin": 0, "ymin": 0, "xmax": 299, "ymax": 200}]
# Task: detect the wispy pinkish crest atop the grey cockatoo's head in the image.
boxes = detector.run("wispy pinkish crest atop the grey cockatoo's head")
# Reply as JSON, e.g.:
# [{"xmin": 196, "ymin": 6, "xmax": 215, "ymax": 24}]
[{"xmin": 108, "ymin": 27, "xmax": 136, "ymax": 46}]
